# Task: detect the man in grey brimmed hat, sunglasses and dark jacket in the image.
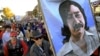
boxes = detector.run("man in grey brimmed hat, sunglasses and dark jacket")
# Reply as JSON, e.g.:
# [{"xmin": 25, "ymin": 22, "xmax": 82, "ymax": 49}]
[{"xmin": 30, "ymin": 31, "xmax": 51, "ymax": 56}]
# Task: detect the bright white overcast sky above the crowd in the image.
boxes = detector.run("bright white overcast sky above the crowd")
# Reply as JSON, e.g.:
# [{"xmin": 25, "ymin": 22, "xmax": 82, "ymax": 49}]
[{"xmin": 0, "ymin": 0, "xmax": 38, "ymax": 15}]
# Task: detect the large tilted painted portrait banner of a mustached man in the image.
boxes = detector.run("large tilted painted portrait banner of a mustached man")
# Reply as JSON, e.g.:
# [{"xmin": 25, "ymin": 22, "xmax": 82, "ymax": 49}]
[{"xmin": 39, "ymin": 0, "xmax": 100, "ymax": 56}]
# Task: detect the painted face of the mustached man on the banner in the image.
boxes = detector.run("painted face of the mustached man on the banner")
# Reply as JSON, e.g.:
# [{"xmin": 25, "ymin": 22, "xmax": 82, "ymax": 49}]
[{"xmin": 66, "ymin": 5, "xmax": 85, "ymax": 36}]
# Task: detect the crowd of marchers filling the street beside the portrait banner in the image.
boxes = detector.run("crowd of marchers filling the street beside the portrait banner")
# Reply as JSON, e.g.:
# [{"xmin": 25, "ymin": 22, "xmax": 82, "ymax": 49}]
[{"xmin": 0, "ymin": 19, "xmax": 53, "ymax": 56}]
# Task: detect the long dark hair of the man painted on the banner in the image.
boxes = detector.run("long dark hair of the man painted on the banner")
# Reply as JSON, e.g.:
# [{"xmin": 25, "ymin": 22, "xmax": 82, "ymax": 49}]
[{"xmin": 59, "ymin": 0, "xmax": 89, "ymax": 42}]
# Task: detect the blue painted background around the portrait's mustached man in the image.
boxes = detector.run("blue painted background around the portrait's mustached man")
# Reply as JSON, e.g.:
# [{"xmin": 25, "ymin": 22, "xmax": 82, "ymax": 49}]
[{"xmin": 40, "ymin": 0, "xmax": 95, "ymax": 53}]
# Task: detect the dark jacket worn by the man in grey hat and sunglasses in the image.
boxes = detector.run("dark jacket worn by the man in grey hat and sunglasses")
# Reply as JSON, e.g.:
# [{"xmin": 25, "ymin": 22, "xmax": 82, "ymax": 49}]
[{"xmin": 30, "ymin": 40, "xmax": 51, "ymax": 56}]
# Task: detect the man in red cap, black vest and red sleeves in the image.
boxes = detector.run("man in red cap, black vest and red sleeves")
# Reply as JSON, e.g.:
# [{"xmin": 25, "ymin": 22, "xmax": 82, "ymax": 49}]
[{"xmin": 4, "ymin": 31, "xmax": 28, "ymax": 56}]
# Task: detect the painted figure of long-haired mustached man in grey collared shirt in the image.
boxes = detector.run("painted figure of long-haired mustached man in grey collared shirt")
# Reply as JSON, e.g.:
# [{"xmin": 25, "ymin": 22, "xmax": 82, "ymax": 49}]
[{"xmin": 57, "ymin": 0, "xmax": 99, "ymax": 56}]
